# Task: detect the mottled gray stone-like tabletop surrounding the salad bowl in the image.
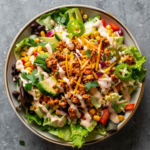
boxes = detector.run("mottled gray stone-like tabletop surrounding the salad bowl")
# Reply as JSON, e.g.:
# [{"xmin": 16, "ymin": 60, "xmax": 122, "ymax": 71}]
[{"xmin": 0, "ymin": 0, "xmax": 150, "ymax": 150}]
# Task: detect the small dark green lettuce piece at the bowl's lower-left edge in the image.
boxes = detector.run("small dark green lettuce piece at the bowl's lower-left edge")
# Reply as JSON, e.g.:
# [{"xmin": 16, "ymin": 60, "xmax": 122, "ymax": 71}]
[{"xmin": 25, "ymin": 114, "xmax": 43, "ymax": 126}]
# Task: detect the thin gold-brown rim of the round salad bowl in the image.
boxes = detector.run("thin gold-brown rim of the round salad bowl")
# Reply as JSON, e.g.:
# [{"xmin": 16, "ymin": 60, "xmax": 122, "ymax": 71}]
[{"xmin": 4, "ymin": 4, "xmax": 145, "ymax": 146}]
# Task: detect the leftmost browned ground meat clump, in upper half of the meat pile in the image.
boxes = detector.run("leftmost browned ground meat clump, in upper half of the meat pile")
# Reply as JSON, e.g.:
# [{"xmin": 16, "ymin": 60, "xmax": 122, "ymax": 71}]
[{"xmin": 45, "ymin": 54, "xmax": 58, "ymax": 69}]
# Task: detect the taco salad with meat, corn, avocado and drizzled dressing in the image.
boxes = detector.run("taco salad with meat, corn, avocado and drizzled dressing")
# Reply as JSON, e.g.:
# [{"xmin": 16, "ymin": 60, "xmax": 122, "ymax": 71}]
[{"xmin": 12, "ymin": 8, "xmax": 146, "ymax": 148}]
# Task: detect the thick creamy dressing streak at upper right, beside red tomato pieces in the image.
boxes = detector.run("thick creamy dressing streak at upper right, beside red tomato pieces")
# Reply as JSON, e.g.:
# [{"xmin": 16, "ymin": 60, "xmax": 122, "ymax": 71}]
[{"xmin": 92, "ymin": 18, "xmax": 114, "ymax": 45}]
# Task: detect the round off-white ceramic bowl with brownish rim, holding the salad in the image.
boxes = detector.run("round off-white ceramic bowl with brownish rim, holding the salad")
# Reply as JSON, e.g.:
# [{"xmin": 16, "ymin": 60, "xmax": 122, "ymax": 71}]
[{"xmin": 4, "ymin": 5, "xmax": 145, "ymax": 146}]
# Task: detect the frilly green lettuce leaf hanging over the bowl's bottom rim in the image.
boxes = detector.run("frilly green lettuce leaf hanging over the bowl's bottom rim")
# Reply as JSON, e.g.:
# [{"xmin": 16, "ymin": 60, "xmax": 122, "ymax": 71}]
[{"xmin": 70, "ymin": 124, "xmax": 88, "ymax": 148}]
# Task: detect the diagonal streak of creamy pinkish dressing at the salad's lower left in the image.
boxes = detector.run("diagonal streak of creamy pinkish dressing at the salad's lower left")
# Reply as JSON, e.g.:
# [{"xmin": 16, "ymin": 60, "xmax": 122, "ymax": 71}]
[{"xmin": 39, "ymin": 104, "xmax": 64, "ymax": 127}]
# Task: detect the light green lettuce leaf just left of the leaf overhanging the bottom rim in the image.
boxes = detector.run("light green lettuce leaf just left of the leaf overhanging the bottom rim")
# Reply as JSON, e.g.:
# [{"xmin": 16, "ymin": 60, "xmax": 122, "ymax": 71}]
[{"xmin": 48, "ymin": 125, "xmax": 72, "ymax": 141}]
